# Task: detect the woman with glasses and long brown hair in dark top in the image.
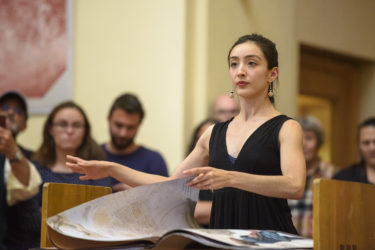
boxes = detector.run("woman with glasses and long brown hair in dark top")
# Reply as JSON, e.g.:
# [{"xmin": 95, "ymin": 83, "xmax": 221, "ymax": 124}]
[{"xmin": 4, "ymin": 101, "xmax": 111, "ymax": 249}]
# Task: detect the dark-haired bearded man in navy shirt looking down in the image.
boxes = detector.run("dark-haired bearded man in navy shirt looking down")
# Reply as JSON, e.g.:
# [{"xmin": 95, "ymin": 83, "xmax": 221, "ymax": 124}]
[{"xmin": 102, "ymin": 93, "xmax": 168, "ymax": 191}]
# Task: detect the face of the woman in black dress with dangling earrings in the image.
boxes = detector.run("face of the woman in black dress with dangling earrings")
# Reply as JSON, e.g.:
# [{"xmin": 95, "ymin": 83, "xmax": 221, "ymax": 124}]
[{"xmin": 229, "ymin": 42, "xmax": 278, "ymax": 98}]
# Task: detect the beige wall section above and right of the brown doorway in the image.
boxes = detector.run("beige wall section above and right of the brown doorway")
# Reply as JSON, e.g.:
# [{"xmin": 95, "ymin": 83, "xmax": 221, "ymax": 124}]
[{"xmin": 296, "ymin": 0, "xmax": 375, "ymax": 121}]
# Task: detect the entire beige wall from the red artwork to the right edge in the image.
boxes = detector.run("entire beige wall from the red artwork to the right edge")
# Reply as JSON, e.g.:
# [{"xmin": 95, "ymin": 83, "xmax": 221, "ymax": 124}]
[{"xmin": 20, "ymin": 0, "xmax": 375, "ymax": 173}]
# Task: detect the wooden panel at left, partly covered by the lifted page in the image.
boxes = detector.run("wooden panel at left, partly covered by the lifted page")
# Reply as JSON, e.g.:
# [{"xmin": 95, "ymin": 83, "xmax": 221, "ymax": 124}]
[{"xmin": 40, "ymin": 183, "xmax": 112, "ymax": 248}]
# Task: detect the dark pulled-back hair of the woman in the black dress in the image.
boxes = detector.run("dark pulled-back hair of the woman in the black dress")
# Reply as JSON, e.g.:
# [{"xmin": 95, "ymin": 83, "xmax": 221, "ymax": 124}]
[{"xmin": 228, "ymin": 34, "xmax": 279, "ymax": 103}]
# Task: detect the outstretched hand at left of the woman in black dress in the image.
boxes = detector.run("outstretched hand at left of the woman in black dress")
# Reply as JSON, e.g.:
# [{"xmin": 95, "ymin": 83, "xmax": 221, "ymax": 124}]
[{"xmin": 66, "ymin": 155, "xmax": 110, "ymax": 180}]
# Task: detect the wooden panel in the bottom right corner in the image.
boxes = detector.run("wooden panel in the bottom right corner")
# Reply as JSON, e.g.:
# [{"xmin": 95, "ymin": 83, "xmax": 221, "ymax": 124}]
[{"xmin": 313, "ymin": 179, "xmax": 375, "ymax": 250}]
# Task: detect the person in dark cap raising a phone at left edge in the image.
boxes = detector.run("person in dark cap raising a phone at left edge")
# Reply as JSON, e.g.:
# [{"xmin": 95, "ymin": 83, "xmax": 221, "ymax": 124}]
[{"xmin": 0, "ymin": 91, "xmax": 41, "ymax": 250}]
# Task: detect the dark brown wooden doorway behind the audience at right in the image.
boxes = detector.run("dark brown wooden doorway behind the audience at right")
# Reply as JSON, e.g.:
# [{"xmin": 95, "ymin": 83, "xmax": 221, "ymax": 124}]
[{"xmin": 298, "ymin": 46, "xmax": 360, "ymax": 168}]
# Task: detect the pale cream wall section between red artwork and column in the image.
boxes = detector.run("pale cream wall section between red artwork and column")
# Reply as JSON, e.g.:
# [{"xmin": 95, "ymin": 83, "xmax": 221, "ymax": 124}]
[{"xmin": 20, "ymin": 0, "xmax": 185, "ymax": 174}]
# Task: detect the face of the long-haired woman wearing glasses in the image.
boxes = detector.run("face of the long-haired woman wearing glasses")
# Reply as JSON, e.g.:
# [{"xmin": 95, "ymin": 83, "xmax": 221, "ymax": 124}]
[{"xmin": 50, "ymin": 108, "xmax": 85, "ymax": 151}]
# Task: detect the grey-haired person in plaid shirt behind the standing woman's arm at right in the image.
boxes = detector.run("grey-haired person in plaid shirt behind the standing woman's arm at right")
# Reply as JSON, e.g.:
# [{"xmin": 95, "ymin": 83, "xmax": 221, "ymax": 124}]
[{"xmin": 288, "ymin": 116, "xmax": 335, "ymax": 238}]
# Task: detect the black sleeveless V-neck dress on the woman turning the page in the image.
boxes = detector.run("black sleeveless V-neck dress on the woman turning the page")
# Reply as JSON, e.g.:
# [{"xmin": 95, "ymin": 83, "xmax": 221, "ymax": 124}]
[{"xmin": 209, "ymin": 115, "xmax": 297, "ymax": 234}]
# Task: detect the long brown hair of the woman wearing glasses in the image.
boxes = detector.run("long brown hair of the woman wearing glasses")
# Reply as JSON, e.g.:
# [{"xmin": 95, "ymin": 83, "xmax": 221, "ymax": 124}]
[{"xmin": 32, "ymin": 101, "xmax": 105, "ymax": 167}]
